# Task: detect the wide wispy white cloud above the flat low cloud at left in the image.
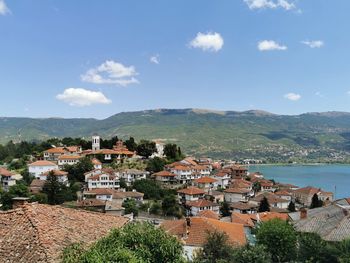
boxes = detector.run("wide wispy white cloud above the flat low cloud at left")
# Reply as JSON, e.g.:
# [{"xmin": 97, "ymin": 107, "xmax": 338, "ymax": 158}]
[{"xmin": 80, "ymin": 60, "xmax": 139, "ymax": 87}]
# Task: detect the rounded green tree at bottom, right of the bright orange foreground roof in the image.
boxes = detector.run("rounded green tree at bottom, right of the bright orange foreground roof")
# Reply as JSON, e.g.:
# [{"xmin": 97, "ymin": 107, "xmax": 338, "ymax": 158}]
[{"xmin": 256, "ymin": 219, "xmax": 297, "ymax": 262}]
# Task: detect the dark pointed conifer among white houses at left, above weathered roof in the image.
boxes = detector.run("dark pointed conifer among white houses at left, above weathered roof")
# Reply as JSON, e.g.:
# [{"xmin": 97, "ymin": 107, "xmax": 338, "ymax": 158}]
[{"xmin": 42, "ymin": 171, "xmax": 66, "ymax": 205}]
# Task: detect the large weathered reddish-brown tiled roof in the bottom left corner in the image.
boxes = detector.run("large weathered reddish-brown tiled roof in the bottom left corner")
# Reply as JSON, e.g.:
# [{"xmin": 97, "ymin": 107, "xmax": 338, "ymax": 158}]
[{"xmin": 0, "ymin": 203, "xmax": 128, "ymax": 263}]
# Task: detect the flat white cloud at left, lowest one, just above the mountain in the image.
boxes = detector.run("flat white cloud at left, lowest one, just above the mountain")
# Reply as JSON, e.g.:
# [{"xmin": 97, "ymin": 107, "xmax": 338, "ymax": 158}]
[{"xmin": 56, "ymin": 88, "xmax": 112, "ymax": 107}]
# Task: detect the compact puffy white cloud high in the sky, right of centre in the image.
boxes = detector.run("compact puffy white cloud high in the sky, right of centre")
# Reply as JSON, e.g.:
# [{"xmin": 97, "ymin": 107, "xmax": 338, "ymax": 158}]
[{"xmin": 190, "ymin": 32, "xmax": 224, "ymax": 52}]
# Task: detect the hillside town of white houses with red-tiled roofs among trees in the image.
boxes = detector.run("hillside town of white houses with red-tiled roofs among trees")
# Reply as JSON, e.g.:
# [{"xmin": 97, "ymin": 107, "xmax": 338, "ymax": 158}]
[{"xmin": 0, "ymin": 134, "xmax": 350, "ymax": 262}]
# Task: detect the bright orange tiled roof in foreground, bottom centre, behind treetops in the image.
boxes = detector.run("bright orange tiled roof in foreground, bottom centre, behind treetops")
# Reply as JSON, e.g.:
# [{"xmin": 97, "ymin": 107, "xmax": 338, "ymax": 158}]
[{"xmin": 161, "ymin": 217, "xmax": 247, "ymax": 247}]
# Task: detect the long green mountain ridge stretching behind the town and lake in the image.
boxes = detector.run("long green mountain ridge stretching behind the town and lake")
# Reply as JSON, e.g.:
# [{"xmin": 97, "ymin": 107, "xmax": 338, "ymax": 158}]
[{"xmin": 0, "ymin": 109, "xmax": 350, "ymax": 161}]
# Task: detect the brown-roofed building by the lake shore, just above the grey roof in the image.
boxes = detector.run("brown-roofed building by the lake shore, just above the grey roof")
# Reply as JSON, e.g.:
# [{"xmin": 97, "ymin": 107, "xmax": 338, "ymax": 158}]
[{"xmin": 293, "ymin": 186, "xmax": 333, "ymax": 206}]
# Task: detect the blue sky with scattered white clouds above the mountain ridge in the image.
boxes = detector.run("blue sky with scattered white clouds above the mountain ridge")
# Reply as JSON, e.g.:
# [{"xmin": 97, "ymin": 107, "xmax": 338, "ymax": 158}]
[{"xmin": 0, "ymin": 0, "xmax": 350, "ymax": 119}]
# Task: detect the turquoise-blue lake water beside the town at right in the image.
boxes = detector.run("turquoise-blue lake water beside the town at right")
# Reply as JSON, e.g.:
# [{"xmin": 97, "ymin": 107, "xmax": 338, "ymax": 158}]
[{"xmin": 249, "ymin": 165, "xmax": 350, "ymax": 199}]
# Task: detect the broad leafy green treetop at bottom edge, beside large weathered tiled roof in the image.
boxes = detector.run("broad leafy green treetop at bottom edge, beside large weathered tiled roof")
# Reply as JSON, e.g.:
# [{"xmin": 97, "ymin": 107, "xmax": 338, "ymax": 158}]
[{"xmin": 63, "ymin": 223, "xmax": 185, "ymax": 263}]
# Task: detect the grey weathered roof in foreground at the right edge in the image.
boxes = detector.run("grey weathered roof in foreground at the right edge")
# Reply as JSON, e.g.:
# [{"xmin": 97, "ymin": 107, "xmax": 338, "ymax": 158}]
[{"xmin": 289, "ymin": 205, "xmax": 350, "ymax": 241}]
